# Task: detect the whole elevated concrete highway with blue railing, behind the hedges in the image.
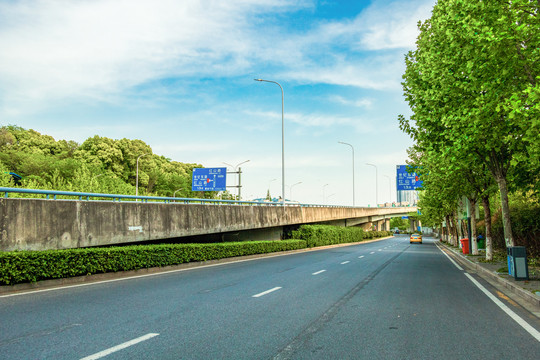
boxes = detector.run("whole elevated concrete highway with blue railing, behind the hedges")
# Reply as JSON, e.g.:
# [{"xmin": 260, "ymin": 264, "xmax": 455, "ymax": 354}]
[{"xmin": 0, "ymin": 188, "xmax": 416, "ymax": 251}]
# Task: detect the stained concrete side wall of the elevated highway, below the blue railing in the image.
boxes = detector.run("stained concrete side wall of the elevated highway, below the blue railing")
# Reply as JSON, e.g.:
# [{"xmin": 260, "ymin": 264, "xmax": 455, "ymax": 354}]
[{"xmin": 0, "ymin": 198, "xmax": 414, "ymax": 251}]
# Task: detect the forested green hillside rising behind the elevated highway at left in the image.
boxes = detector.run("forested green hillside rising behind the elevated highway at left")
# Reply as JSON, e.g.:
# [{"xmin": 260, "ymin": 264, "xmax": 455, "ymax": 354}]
[{"xmin": 0, "ymin": 126, "xmax": 213, "ymax": 197}]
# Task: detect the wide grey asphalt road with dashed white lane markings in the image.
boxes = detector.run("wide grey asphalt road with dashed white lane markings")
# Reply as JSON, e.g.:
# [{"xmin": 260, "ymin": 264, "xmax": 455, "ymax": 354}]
[{"xmin": 0, "ymin": 236, "xmax": 540, "ymax": 360}]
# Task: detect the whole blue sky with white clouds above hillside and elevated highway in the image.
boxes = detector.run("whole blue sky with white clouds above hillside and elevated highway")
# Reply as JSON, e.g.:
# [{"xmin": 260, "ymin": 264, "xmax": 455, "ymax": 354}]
[{"xmin": 0, "ymin": 0, "xmax": 435, "ymax": 206}]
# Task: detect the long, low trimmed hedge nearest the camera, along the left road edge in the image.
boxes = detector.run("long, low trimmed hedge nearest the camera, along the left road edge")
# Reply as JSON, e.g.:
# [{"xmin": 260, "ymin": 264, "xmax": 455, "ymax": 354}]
[{"xmin": 0, "ymin": 240, "xmax": 306, "ymax": 285}]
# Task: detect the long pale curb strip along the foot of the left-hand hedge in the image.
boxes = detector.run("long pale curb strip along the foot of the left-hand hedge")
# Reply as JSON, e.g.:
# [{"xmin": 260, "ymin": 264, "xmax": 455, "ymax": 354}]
[{"xmin": 0, "ymin": 236, "xmax": 393, "ymax": 297}]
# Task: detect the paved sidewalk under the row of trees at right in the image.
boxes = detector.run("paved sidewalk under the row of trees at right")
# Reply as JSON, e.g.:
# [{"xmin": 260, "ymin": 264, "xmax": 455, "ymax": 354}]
[{"xmin": 437, "ymin": 241, "xmax": 540, "ymax": 317}]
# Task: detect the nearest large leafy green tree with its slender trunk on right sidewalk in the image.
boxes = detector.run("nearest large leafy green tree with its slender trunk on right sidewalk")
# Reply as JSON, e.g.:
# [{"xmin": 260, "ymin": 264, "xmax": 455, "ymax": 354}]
[{"xmin": 400, "ymin": 0, "xmax": 539, "ymax": 250}]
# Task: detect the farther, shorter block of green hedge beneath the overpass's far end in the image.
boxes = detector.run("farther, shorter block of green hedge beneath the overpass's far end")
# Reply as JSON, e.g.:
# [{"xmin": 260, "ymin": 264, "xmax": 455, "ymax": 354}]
[{"xmin": 291, "ymin": 225, "xmax": 392, "ymax": 247}]
